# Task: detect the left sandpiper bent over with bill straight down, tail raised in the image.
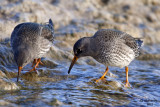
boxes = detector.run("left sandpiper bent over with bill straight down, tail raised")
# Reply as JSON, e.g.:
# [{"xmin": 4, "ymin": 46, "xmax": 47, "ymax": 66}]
[{"xmin": 11, "ymin": 19, "xmax": 54, "ymax": 82}]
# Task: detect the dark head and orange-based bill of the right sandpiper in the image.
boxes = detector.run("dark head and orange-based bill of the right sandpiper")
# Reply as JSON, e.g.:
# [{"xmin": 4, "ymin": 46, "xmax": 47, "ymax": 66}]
[{"xmin": 68, "ymin": 37, "xmax": 94, "ymax": 74}]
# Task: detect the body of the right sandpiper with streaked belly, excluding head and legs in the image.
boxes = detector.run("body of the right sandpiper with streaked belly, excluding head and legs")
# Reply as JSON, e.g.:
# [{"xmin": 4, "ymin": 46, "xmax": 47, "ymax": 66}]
[{"xmin": 93, "ymin": 29, "xmax": 142, "ymax": 67}]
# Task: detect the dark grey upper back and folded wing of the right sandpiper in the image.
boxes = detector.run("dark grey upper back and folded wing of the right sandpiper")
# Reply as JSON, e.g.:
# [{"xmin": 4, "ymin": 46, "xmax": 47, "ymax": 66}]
[{"xmin": 93, "ymin": 29, "xmax": 143, "ymax": 56}]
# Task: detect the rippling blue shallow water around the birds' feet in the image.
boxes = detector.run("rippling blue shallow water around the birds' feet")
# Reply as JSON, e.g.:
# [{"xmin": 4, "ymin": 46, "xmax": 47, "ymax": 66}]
[{"xmin": 0, "ymin": 46, "xmax": 160, "ymax": 106}]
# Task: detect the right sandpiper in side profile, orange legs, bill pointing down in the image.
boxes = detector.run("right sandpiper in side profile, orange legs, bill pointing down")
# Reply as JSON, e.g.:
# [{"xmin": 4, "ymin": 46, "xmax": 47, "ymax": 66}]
[{"xmin": 68, "ymin": 29, "xmax": 143, "ymax": 87}]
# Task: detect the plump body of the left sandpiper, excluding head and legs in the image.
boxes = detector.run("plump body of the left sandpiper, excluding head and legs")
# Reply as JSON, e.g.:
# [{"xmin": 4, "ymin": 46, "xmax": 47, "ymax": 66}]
[{"xmin": 11, "ymin": 19, "xmax": 54, "ymax": 58}]
